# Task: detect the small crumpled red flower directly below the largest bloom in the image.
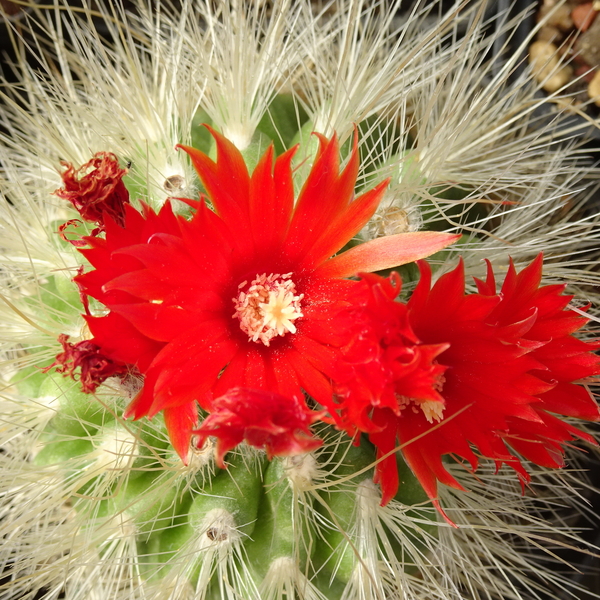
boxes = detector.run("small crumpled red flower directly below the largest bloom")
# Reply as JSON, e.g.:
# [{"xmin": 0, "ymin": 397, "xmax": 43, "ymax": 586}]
[{"xmin": 194, "ymin": 388, "xmax": 324, "ymax": 468}]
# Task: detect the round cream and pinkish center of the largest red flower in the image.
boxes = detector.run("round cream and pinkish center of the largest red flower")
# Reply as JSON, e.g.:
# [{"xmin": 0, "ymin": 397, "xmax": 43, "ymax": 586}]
[{"xmin": 233, "ymin": 273, "xmax": 304, "ymax": 346}]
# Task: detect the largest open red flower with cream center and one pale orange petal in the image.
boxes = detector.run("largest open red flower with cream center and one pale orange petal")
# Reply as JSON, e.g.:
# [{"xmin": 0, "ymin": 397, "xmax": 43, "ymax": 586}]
[{"xmin": 70, "ymin": 130, "xmax": 457, "ymax": 460}]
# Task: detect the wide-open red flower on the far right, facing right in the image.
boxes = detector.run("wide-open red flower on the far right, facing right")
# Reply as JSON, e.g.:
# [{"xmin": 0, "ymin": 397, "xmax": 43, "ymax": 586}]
[{"xmin": 341, "ymin": 255, "xmax": 600, "ymax": 514}]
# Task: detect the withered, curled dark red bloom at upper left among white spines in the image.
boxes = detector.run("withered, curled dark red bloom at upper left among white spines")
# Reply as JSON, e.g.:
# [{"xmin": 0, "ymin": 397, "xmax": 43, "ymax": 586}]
[{"xmin": 54, "ymin": 152, "xmax": 129, "ymax": 234}]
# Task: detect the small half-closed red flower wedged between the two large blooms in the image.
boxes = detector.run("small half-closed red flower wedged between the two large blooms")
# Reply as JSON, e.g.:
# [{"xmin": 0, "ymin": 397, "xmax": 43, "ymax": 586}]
[{"xmin": 336, "ymin": 273, "xmax": 448, "ymax": 436}]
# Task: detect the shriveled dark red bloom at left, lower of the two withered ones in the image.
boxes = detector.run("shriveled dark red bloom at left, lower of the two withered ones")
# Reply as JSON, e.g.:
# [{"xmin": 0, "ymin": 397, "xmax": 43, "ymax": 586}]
[{"xmin": 43, "ymin": 333, "xmax": 130, "ymax": 394}]
